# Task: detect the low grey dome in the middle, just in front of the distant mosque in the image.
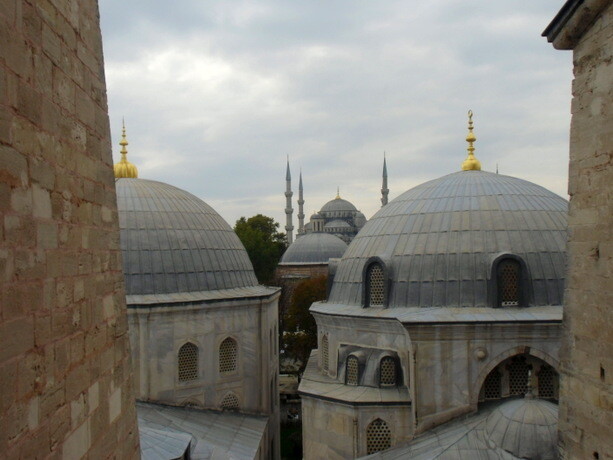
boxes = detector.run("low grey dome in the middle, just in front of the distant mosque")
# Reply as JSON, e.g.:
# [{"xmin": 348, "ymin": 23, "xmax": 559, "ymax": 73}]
[{"xmin": 279, "ymin": 233, "xmax": 347, "ymax": 265}]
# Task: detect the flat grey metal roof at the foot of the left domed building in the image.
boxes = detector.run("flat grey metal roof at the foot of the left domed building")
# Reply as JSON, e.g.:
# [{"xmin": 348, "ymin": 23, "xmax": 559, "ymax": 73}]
[{"xmin": 136, "ymin": 402, "xmax": 268, "ymax": 460}]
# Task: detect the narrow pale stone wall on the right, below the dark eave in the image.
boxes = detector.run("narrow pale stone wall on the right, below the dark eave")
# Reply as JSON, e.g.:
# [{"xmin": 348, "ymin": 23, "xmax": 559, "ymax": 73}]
[{"xmin": 559, "ymin": 2, "xmax": 613, "ymax": 459}]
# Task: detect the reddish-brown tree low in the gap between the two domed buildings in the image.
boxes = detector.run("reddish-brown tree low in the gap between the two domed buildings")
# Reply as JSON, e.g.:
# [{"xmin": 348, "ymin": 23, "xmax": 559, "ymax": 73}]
[{"xmin": 282, "ymin": 276, "xmax": 328, "ymax": 372}]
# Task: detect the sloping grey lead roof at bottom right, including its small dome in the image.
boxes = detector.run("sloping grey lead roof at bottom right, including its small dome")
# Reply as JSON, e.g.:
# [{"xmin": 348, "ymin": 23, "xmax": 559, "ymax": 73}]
[{"xmin": 363, "ymin": 398, "xmax": 558, "ymax": 460}]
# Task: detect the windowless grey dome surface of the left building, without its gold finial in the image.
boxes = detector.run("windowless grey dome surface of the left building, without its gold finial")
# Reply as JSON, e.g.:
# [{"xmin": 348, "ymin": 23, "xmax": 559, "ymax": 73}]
[{"xmin": 115, "ymin": 179, "xmax": 258, "ymax": 295}]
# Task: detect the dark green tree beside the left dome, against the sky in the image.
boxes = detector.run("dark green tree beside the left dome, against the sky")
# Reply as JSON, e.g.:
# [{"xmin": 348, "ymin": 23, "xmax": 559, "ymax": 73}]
[{"xmin": 234, "ymin": 214, "xmax": 287, "ymax": 284}]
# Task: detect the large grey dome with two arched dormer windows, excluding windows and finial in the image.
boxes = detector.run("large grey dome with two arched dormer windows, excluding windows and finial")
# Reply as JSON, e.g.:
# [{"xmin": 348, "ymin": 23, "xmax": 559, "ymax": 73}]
[{"xmin": 329, "ymin": 171, "xmax": 568, "ymax": 307}]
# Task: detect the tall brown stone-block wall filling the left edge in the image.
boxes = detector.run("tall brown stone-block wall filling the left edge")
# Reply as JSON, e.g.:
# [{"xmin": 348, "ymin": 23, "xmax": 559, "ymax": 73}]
[{"xmin": 0, "ymin": 0, "xmax": 138, "ymax": 459}]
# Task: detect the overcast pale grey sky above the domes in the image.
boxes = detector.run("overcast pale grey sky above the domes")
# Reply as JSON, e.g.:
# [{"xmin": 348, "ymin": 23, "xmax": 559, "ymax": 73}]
[{"xmin": 100, "ymin": 0, "xmax": 572, "ymax": 228}]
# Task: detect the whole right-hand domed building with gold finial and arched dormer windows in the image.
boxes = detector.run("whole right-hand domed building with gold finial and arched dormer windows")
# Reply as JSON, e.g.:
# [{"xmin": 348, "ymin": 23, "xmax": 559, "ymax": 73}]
[{"xmin": 299, "ymin": 112, "xmax": 568, "ymax": 459}]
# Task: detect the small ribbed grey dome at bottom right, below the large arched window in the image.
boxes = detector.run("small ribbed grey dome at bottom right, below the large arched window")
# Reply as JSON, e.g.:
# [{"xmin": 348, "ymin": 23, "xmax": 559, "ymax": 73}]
[{"xmin": 485, "ymin": 398, "xmax": 558, "ymax": 460}]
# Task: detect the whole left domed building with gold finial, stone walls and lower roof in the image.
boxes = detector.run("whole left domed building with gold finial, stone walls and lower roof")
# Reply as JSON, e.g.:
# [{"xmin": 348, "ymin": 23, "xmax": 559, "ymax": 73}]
[{"xmin": 114, "ymin": 126, "xmax": 279, "ymax": 459}]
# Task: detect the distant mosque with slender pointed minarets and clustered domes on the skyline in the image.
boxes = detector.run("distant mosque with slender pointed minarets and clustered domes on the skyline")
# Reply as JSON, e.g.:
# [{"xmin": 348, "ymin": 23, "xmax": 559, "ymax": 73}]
[{"xmin": 285, "ymin": 157, "xmax": 389, "ymax": 245}]
